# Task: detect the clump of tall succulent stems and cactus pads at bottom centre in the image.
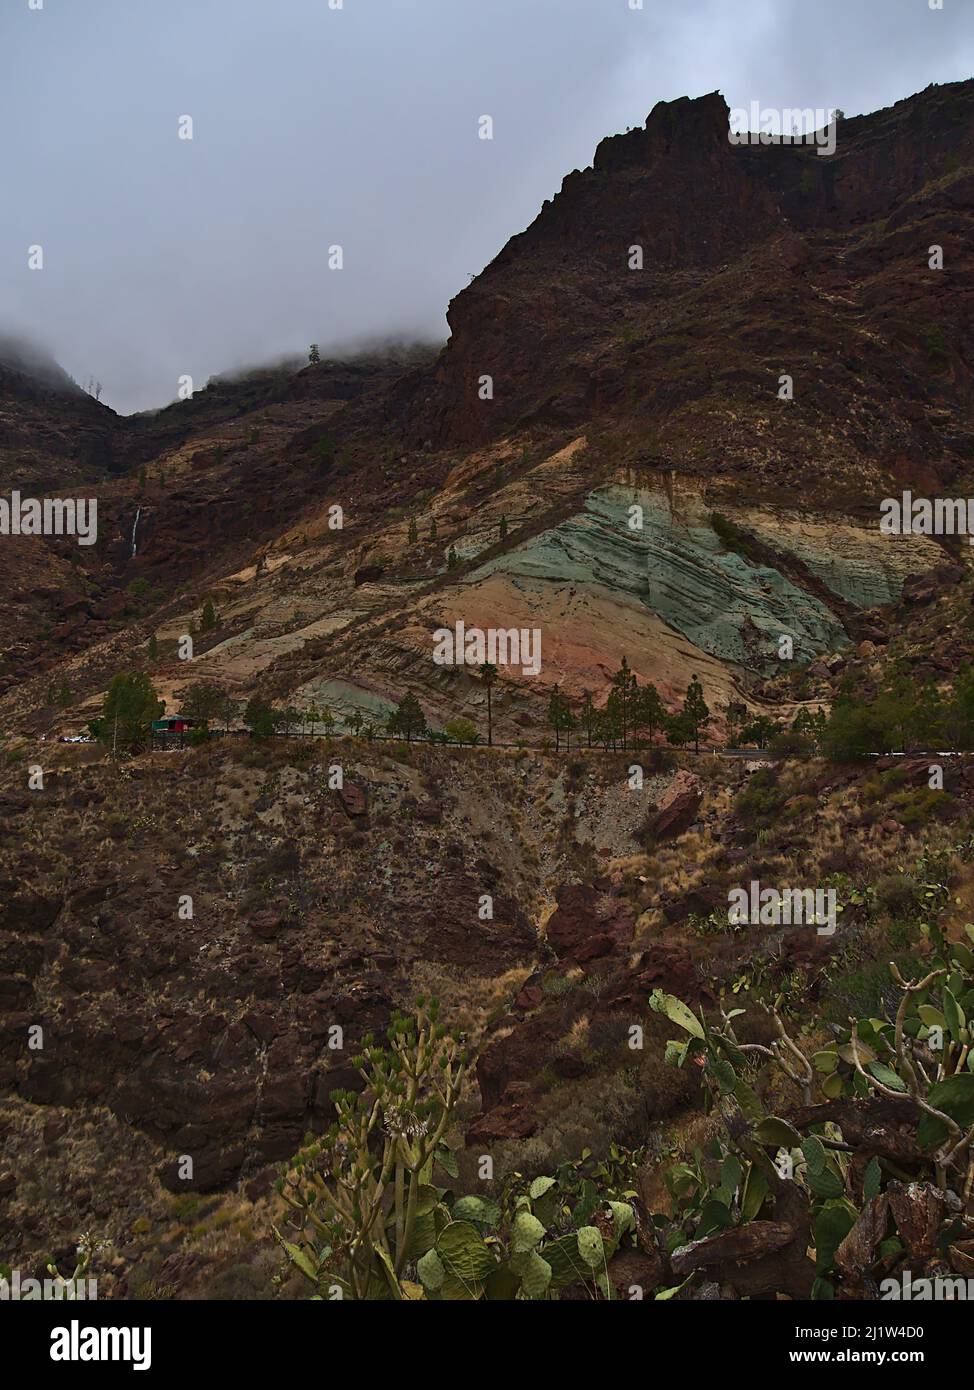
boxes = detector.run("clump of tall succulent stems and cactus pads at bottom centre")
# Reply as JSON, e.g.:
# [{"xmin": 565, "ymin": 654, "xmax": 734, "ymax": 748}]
[{"xmin": 275, "ymin": 1001, "xmax": 642, "ymax": 1301}]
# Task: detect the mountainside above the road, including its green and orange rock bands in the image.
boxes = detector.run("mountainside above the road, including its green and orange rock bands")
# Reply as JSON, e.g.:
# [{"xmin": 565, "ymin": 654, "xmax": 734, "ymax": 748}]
[{"xmin": 0, "ymin": 83, "xmax": 974, "ymax": 738}]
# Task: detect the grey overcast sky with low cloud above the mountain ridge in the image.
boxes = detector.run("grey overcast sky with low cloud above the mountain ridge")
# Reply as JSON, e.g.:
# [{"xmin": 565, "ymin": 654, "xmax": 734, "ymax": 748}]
[{"xmin": 0, "ymin": 0, "xmax": 974, "ymax": 413}]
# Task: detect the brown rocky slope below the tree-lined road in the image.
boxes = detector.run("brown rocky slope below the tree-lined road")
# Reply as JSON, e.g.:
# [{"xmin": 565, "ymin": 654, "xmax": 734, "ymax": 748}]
[{"xmin": 0, "ymin": 739, "xmax": 974, "ymax": 1297}]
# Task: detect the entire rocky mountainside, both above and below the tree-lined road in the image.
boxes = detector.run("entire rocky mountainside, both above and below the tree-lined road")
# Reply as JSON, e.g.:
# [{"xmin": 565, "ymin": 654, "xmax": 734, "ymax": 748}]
[{"xmin": 0, "ymin": 83, "xmax": 974, "ymax": 1291}]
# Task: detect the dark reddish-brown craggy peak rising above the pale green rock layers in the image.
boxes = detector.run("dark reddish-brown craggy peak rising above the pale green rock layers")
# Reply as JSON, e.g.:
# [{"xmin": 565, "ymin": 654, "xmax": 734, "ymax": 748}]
[{"xmin": 394, "ymin": 82, "xmax": 974, "ymax": 487}]
